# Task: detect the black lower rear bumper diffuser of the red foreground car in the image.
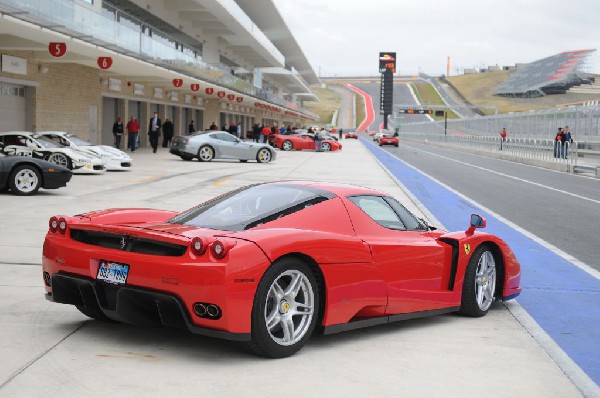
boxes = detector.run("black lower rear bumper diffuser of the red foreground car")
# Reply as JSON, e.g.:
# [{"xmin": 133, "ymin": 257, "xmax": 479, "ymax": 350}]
[{"xmin": 46, "ymin": 273, "xmax": 250, "ymax": 341}]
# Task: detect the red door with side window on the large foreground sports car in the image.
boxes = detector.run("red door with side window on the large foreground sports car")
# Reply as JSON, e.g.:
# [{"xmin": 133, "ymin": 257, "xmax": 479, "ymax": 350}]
[{"xmin": 348, "ymin": 195, "xmax": 454, "ymax": 314}]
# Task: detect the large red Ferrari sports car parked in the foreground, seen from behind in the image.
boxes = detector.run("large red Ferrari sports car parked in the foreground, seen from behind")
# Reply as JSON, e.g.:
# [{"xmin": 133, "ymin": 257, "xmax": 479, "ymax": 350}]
[{"xmin": 43, "ymin": 181, "xmax": 521, "ymax": 357}]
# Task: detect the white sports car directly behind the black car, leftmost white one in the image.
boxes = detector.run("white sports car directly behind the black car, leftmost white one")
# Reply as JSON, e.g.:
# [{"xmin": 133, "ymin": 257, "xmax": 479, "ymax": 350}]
[{"xmin": 0, "ymin": 131, "xmax": 106, "ymax": 174}]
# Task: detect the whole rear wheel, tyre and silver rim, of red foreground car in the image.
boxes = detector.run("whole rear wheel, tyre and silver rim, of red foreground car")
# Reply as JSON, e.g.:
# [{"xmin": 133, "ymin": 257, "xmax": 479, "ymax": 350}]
[{"xmin": 248, "ymin": 258, "xmax": 319, "ymax": 358}]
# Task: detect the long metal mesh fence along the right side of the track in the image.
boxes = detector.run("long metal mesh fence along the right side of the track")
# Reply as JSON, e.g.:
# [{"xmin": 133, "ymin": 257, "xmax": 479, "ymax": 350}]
[{"xmin": 394, "ymin": 105, "xmax": 600, "ymax": 145}]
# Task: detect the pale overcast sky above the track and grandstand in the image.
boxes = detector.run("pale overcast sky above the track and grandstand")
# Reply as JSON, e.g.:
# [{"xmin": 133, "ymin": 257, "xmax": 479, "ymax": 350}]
[{"xmin": 273, "ymin": 0, "xmax": 600, "ymax": 76}]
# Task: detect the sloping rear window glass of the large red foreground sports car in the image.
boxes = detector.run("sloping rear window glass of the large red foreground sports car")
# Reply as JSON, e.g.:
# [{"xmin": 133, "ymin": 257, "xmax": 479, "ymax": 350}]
[{"xmin": 168, "ymin": 184, "xmax": 334, "ymax": 231}]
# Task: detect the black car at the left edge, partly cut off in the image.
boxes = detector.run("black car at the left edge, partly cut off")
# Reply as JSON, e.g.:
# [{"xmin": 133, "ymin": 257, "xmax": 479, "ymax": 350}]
[{"xmin": 0, "ymin": 153, "xmax": 73, "ymax": 195}]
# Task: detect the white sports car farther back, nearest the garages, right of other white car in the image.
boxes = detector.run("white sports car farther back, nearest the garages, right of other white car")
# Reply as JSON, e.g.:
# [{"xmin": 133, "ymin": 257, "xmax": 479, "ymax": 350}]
[{"xmin": 35, "ymin": 131, "xmax": 133, "ymax": 171}]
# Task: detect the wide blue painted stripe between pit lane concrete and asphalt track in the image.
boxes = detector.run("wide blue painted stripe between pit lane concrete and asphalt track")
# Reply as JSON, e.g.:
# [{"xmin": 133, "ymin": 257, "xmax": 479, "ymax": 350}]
[{"xmin": 360, "ymin": 137, "xmax": 600, "ymax": 384}]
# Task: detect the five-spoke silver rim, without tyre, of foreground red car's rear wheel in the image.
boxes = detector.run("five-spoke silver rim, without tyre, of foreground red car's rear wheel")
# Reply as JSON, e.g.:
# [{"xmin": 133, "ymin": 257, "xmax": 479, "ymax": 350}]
[{"xmin": 264, "ymin": 270, "xmax": 315, "ymax": 346}]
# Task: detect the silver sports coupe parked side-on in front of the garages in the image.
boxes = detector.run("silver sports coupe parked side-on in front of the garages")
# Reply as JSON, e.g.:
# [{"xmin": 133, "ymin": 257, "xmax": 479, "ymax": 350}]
[{"xmin": 170, "ymin": 131, "xmax": 276, "ymax": 163}]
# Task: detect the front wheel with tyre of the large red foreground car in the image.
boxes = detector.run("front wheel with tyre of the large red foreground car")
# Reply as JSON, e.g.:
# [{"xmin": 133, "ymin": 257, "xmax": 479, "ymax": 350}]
[{"xmin": 460, "ymin": 245, "xmax": 497, "ymax": 317}]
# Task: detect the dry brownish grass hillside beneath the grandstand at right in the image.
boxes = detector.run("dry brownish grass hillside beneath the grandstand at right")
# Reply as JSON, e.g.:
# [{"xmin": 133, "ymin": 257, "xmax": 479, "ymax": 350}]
[{"xmin": 447, "ymin": 71, "xmax": 600, "ymax": 114}]
